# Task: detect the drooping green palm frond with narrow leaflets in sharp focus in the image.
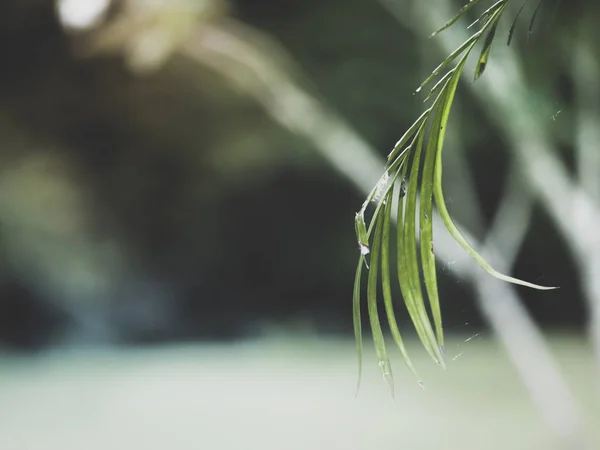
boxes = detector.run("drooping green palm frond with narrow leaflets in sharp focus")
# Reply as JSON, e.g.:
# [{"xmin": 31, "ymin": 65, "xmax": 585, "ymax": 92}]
[{"xmin": 353, "ymin": 0, "xmax": 554, "ymax": 392}]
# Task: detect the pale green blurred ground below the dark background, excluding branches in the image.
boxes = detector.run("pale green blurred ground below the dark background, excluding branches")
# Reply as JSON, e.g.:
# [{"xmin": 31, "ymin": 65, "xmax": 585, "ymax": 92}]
[{"xmin": 0, "ymin": 336, "xmax": 600, "ymax": 450}]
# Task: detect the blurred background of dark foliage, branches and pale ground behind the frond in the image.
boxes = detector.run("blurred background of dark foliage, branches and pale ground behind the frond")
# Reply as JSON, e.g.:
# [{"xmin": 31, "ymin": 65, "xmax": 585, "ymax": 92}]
[{"xmin": 0, "ymin": 0, "xmax": 600, "ymax": 450}]
